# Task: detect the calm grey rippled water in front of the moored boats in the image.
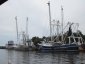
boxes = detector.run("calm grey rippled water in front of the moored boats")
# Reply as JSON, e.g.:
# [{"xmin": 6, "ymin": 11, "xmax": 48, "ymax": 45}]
[{"xmin": 0, "ymin": 50, "xmax": 85, "ymax": 64}]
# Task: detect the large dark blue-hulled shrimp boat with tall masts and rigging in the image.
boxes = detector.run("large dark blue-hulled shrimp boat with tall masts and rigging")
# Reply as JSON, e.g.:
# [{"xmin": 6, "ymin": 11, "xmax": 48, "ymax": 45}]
[{"xmin": 38, "ymin": 2, "xmax": 79, "ymax": 52}]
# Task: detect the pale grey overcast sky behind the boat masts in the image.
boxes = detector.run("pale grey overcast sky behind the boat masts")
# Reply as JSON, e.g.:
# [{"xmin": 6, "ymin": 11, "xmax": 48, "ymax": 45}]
[{"xmin": 0, "ymin": 0, "xmax": 85, "ymax": 45}]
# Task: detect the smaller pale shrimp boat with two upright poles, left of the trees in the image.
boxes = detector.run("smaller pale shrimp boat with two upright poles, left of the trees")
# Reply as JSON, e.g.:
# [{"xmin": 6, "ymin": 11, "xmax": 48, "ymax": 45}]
[{"xmin": 14, "ymin": 17, "xmax": 29, "ymax": 51}]
